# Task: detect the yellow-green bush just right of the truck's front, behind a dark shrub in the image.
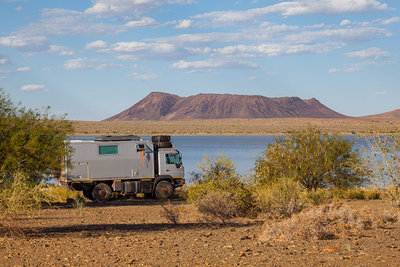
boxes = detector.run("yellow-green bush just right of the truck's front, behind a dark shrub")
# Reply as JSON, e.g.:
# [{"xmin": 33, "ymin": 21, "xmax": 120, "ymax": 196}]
[{"xmin": 187, "ymin": 154, "xmax": 256, "ymax": 216}]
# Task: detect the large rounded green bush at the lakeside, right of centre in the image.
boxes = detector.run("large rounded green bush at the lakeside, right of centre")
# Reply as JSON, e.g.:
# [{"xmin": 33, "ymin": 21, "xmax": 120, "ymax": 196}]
[{"xmin": 255, "ymin": 128, "xmax": 365, "ymax": 189}]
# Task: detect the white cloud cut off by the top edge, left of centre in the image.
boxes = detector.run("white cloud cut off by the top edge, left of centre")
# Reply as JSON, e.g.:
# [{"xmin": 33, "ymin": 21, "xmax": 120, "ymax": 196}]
[{"xmin": 85, "ymin": 0, "xmax": 193, "ymax": 17}]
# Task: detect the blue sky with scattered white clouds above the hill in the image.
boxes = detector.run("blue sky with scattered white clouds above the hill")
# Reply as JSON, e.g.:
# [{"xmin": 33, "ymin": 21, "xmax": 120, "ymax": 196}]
[{"xmin": 0, "ymin": 0, "xmax": 400, "ymax": 120}]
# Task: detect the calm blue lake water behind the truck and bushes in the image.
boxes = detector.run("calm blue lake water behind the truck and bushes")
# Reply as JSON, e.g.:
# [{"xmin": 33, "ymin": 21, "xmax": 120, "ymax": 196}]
[{"xmin": 72, "ymin": 135, "xmax": 362, "ymax": 181}]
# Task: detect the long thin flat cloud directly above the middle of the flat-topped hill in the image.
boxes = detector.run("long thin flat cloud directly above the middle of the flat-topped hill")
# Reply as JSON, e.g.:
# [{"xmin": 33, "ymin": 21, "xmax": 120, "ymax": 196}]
[{"xmin": 172, "ymin": 58, "xmax": 259, "ymax": 71}]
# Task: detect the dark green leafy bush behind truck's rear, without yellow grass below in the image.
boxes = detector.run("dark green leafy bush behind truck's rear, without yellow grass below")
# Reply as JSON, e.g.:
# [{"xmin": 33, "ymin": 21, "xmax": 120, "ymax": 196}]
[{"xmin": 0, "ymin": 89, "xmax": 72, "ymax": 187}]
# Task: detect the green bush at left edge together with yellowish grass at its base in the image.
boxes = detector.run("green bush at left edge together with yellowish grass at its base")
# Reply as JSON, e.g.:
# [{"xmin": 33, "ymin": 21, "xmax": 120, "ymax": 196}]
[{"xmin": 0, "ymin": 88, "xmax": 73, "ymax": 217}]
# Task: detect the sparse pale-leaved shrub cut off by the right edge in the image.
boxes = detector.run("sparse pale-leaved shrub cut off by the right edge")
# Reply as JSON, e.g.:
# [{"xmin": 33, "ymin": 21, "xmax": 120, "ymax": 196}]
[{"xmin": 363, "ymin": 133, "xmax": 400, "ymax": 207}]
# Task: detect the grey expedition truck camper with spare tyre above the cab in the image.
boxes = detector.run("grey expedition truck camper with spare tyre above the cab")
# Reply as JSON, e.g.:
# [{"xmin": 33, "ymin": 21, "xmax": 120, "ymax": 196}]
[{"xmin": 59, "ymin": 135, "xmax": 185, "ymax": 202}]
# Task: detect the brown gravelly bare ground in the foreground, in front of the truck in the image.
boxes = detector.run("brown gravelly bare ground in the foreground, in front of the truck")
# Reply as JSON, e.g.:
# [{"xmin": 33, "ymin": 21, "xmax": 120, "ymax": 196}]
[{"xmin": 0, "ymin": 199, "xmax": 400, "ymax": 266}]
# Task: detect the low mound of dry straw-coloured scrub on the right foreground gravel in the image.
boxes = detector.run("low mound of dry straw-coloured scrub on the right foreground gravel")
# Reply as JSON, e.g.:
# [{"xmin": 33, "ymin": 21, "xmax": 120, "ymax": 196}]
[{"xmin": 260, "ymin": 203, "xmax": 399, "ymax": 241}]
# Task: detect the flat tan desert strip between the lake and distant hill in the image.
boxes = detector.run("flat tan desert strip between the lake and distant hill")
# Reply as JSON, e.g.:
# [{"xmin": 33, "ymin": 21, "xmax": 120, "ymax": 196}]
[{"xmin": 72, "ymin": 118, "xmax": 400, "ymax": 135}]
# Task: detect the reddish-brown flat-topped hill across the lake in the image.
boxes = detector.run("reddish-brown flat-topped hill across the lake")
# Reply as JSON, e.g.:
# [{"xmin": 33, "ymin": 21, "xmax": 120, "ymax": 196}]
[{"xmin": 106, "ymin": 92, "xmax": 346, "ymax": 121}]
